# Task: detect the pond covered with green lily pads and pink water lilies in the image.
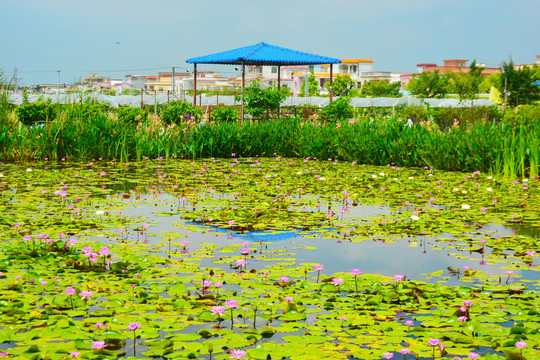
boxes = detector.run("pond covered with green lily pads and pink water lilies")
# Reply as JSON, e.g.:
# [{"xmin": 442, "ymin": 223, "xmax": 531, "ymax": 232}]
[{"xmin": 0, "ymin": 156, "xmax": 540, "ymax": 360}]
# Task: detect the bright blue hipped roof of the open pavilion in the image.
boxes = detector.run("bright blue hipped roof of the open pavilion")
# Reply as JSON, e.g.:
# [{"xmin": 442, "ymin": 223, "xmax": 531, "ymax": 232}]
[{"xmin": 186, "ymin": 42, "xmax": 341, "ymax": 65}]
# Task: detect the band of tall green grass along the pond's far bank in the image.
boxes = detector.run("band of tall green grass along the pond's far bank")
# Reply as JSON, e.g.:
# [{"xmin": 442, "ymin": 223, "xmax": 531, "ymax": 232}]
[{"xmin": 0, "ymin": 102, "xmax": 540, "ymax": 177}]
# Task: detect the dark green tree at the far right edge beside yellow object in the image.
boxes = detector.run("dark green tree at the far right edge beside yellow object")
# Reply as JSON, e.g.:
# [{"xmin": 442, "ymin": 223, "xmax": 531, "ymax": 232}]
[{"xmin": 497, "ymin": 58, "xmax": 540, "ymax": 106}]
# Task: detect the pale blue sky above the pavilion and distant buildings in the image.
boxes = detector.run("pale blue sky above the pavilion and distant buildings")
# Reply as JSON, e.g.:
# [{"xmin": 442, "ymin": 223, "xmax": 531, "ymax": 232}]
[{"xmin": 0, "ymin": 0, "xmax": 540, "ymax": 85}]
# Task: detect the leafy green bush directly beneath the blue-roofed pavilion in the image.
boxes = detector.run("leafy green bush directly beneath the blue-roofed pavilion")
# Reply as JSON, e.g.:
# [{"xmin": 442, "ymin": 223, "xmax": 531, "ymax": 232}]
[{"xmin": 244, "ymin": 80, "xmax": 288, "ymax": 118}]
